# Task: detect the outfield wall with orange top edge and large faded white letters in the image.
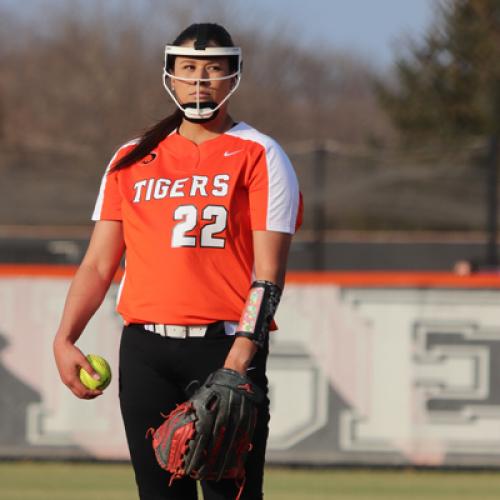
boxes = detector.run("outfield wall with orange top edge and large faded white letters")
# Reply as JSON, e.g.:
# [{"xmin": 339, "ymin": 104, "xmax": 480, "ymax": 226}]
[{"xmin": 0, "ymin": 266, "xmax": 500, "ymax": 466}]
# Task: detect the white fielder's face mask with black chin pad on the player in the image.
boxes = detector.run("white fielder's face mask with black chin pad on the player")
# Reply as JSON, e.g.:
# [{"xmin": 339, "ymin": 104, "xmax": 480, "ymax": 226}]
[{"xmin": 163, "ymin": 45, "xmax": 242, "ymax": 123}]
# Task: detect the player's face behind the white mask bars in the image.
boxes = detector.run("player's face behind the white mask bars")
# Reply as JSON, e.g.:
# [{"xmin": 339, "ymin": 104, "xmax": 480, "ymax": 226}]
[{"xmin": 171, "ymin": 43, "xmax": 234, "ymax": 104}]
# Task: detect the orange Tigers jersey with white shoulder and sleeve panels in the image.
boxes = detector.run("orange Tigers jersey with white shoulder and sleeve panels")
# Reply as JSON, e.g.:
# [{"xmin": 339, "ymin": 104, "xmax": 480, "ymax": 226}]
[{"xmin": 92, "ymin": 123, "xmax": 301, "ymax": 325}]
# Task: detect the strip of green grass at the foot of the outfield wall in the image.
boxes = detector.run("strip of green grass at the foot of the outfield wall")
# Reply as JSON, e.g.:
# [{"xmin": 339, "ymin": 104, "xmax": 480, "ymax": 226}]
[{"xmin": 0, "ymin": 462, "xmax": 500, "ymax": 500}]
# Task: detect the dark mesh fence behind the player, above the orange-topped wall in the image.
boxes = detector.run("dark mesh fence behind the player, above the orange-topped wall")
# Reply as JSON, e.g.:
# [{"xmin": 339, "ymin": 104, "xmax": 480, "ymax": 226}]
[{"xmin": 0, "ymin": 141, "xmax": 498, "ymax": 269}]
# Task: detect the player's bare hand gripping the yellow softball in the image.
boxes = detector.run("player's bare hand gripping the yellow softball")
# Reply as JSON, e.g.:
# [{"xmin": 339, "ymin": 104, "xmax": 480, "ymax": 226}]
[{"xmin": 53, "ymin": 337, "xmax": 102, "ymax": 399}]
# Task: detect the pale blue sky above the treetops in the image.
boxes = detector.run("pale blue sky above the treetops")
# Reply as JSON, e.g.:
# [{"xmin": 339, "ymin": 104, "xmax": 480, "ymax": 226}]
[{"xmin": 0, "ymin": 0, "xmax": 438, "ymax": 67}]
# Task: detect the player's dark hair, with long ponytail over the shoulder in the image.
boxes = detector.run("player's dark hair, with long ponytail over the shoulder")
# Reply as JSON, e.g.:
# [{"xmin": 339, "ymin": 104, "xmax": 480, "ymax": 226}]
[{"xmin": 111, "ymin": 23, "xmax": 234, "ymax": 171}]
